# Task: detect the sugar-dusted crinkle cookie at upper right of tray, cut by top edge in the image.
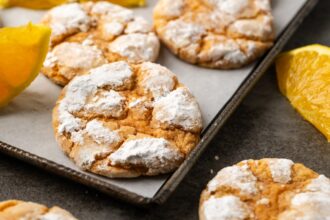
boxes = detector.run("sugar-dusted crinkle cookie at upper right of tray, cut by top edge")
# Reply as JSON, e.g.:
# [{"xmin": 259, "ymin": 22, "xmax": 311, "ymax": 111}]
[{"xmin": 154, "ymin": 0, "xmax": 274, "ymax": 69}]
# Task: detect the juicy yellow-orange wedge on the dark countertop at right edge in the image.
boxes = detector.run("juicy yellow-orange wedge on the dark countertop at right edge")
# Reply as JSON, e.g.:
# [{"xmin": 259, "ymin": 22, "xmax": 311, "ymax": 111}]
[{"xmin": 276, "ymin": 45, "xmax": 330, "ymax": 141}]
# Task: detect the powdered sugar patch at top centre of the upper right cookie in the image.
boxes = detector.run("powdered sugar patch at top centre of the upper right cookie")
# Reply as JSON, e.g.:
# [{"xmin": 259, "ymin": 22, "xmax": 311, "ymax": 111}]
[{"xmin": 208, "ymin": 0, "xmax": 249, "ymax": 16}]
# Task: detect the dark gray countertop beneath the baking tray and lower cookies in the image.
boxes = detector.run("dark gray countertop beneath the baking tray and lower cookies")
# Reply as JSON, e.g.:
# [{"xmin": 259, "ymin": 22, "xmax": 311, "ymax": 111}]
[{"xmin": 0, "ymin": 0, "xmax": 330, "ymax": 220}]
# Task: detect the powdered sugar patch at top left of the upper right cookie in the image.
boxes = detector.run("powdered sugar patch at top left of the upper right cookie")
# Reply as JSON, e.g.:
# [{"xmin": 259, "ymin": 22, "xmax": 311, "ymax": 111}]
[{"xmin": 155, "ymin": 0, "xmax": 184, "ymax": 18}]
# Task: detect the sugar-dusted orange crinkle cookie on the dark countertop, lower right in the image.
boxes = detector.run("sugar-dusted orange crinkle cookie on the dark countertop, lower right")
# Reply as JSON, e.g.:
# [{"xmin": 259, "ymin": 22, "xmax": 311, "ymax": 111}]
[{"xmin": 199, "ymin": 158, "xmax": 330, "ymax": 220}]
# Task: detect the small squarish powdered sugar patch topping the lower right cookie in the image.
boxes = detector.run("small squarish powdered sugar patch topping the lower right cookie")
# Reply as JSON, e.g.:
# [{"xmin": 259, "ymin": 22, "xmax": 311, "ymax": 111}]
[{"xmin": 267, "ymin": 159, "xmax": 294, "ymax": 184}]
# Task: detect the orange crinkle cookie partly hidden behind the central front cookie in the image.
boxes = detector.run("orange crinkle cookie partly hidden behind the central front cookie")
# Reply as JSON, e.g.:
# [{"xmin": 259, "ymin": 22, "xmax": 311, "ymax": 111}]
[{"xmin": 41, "ymin": 1, "xmax": 160, "ymax": 85}]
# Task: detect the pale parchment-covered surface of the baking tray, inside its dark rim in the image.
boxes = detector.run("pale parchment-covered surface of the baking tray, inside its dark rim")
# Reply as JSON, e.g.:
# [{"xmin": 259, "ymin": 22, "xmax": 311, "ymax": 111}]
[{"xmin": 0, "ymin": 0, "xmax": 308, "ymax": 202}]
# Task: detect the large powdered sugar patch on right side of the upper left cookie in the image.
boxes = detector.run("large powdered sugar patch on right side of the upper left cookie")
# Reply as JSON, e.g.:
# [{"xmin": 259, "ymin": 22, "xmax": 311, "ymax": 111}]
[{"xmin": 108, "ymin": 33, "xmax": 160, "ymax": 62}]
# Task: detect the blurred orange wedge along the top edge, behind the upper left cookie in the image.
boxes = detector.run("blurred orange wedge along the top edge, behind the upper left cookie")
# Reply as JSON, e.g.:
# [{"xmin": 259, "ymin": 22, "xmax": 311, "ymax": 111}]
[{"xmin": 0, "ymin": 0, "xmax": 145, "ymax": 9}]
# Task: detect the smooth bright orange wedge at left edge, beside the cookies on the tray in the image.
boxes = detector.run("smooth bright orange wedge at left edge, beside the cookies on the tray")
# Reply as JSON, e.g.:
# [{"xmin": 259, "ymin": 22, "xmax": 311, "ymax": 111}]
[{"xmin": 0, "ymin": 24, "xmax": 51, "ymax": 107}]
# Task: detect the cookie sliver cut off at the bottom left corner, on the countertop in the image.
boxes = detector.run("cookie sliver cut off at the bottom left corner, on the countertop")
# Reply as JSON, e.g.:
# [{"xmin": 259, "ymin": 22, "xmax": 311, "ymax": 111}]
[{"xmin": 0, "ymin": 200, "xmax": 77, "ymax": 220}]
